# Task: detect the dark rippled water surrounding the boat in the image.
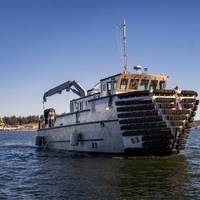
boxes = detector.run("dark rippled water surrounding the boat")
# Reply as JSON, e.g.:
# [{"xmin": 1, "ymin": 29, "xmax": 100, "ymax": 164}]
[{"xmin": 0, "ymin": 130, "xmax": 200, "ymax": 200}]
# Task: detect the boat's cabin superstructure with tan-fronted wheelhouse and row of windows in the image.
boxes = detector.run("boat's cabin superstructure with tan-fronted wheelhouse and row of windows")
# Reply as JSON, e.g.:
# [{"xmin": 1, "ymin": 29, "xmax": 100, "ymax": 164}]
[{"xmin": 70, "ymin": 72, "xmax": 167, "ymax": 112}]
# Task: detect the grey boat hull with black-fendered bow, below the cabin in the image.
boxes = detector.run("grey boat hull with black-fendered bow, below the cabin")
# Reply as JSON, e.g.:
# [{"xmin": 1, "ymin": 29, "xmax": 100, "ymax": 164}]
[{"xmin": 36, "ymin": 90, "xmax": 199, "ymax": 156}]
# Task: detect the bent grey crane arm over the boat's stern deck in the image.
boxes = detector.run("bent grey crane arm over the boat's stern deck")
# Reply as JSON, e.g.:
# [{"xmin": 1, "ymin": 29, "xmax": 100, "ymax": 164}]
[{"xmin": 43, "ymin": 81, "xmax": 86, "ymax": 102}]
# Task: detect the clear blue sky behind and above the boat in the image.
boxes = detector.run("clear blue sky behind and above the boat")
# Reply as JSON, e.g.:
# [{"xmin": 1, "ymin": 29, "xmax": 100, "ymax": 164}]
[{"xmin": 0, "ymin": 0, "xmax": 200, "ymax": 118}]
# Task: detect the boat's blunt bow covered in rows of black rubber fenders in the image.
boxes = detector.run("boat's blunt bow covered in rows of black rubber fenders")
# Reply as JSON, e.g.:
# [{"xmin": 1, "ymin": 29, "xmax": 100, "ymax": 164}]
[{"xmin": 116, "ymin": 90, "xmax": 199, "ymax": 155}]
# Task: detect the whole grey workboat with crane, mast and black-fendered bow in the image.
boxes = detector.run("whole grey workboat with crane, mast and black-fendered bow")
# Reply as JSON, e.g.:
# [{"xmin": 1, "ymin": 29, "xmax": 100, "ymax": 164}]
[{"xmin": 36, "ymin": 21, "xmax": 199, "ymax": 156}]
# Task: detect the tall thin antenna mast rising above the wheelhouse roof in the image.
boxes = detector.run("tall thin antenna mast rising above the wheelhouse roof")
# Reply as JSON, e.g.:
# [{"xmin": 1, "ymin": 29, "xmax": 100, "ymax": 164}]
[{"xmin": 121, "ymin": 19, "xmax": 128, "ymax": 72}]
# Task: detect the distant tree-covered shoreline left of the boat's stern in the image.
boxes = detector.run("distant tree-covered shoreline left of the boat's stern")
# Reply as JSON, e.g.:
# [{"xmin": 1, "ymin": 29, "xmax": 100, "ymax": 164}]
[{"xmin": 2, "ymin": 115, "xmax": 43, "ymax": 126}]
